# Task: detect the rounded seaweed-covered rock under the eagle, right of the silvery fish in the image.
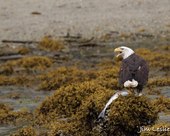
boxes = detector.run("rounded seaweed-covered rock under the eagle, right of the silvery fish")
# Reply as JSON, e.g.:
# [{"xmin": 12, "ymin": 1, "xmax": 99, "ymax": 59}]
[{"xmin": 99, "ymin": 95, "xmax": 158, "ymax": 136}]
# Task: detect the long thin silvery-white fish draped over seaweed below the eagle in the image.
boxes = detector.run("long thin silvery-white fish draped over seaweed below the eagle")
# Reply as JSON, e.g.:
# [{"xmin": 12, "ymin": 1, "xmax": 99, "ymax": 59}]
[{"xmin": 98, "ymin": 91, "xmax": 129, "ymax": 118}]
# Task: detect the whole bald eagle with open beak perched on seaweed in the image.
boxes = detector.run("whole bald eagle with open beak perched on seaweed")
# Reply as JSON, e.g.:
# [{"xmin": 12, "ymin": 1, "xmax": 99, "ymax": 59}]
[{"xmin": 114, "ymin": 46, "xmax": 149, "ymax": 95}]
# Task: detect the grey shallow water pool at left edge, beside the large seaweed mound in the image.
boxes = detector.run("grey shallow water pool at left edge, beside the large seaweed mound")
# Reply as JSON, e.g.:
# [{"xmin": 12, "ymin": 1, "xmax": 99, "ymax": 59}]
[{"xmin": 0, "ymin": 86, "xmax": 50, "ymax": 111}]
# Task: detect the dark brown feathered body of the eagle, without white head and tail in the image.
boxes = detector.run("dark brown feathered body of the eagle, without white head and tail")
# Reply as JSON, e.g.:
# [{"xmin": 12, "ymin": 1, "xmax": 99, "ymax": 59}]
[{"xmin": 119, "ymin": 53, "xmax": 149, "ymax": 92}]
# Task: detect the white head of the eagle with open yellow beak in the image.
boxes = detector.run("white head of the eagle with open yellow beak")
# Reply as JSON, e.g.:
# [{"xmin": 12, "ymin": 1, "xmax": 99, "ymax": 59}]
[{"xmin": 114, "ymin": 46, "xmax": 134, "ymax": 59}]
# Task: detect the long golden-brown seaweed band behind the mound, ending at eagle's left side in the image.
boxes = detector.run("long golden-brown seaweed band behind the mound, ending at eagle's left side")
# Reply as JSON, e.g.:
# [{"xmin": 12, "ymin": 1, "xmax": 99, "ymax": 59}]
[{"xmin": 38, "ymin": 67, "xmax": 119, "ymax": 91}]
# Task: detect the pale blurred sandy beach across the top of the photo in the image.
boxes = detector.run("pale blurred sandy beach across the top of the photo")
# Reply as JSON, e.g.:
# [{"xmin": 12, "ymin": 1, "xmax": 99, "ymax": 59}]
[{"xmin": 0, "ymin": 0, "xmax": 170, "ymax": 40}]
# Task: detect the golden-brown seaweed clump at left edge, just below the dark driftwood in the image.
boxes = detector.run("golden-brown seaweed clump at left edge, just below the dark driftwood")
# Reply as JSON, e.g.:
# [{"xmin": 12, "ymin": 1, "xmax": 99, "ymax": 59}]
[{"xmin": 0, "ymin": 56, "xmax": 53, "ymax": 75}]
